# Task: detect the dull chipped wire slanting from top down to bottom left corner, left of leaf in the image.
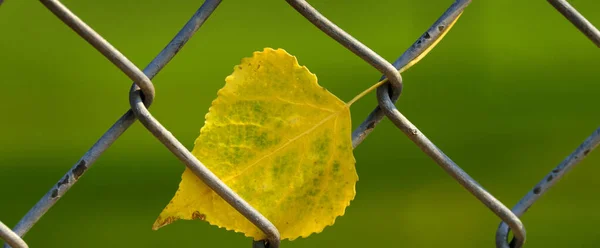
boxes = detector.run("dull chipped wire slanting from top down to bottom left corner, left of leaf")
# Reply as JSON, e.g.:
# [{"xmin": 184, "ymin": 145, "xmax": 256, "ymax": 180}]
[{"xmin": 4, "ymin": 0, "xmax": 221, "ymax": 244}]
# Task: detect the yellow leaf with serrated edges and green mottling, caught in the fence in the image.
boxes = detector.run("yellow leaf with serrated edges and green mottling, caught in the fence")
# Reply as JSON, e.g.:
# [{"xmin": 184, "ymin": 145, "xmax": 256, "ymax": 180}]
[{"xmin": 153, "ymin": 48, "xmax": 358, "ymax": 240}]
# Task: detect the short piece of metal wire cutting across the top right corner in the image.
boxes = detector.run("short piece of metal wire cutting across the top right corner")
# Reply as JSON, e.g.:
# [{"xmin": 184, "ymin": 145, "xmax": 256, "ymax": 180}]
[{"xmin": 548, "ymin": 0, "xmax": 600, "ymax": 47}]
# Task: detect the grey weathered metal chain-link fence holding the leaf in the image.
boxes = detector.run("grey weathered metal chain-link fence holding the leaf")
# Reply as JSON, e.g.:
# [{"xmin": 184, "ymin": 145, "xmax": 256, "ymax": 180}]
[{"xmin": 0, "ymin": 0, "xmax": 600, "ymax": 248}]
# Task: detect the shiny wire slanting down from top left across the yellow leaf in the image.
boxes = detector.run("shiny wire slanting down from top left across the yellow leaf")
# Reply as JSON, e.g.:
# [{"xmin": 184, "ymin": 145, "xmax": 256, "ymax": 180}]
[{"xmin": 35, "ymin": 0, "xmax": 279, "ymax": 248}]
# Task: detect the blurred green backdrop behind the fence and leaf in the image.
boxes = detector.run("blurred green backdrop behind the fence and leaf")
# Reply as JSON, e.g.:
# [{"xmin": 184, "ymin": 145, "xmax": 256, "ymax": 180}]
[{"xmin": 0, "ymin": 0, "xmax": 600, "ymax": 247}]
